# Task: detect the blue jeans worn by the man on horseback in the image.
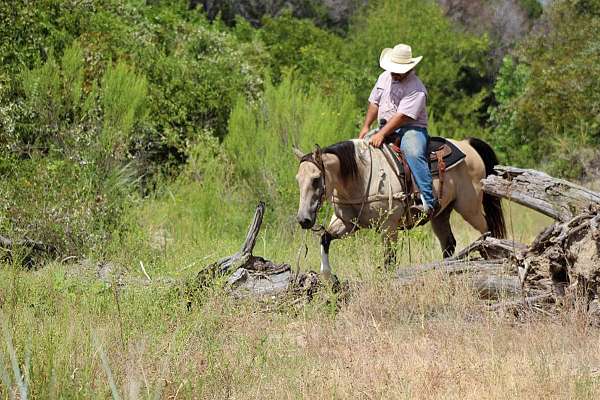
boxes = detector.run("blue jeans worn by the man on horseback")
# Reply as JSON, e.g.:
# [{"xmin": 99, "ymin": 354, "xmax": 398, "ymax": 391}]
[{"xmin": 392, "ymin": 126, "xmax": 435, "ymax": 208}]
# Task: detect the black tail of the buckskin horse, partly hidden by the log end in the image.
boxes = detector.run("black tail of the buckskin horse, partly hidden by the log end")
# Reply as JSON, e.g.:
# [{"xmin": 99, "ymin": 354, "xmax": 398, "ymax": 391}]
[{"xmin": 469, "ymin": 138, "xmax": 506, "ymax": 239}]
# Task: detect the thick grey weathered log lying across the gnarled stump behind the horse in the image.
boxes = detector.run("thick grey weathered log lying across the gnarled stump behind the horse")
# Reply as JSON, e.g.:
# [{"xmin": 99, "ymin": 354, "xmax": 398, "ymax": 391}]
[{"xmin": 483, "ymin": 165, "xmax": 600, "ymax": 222}]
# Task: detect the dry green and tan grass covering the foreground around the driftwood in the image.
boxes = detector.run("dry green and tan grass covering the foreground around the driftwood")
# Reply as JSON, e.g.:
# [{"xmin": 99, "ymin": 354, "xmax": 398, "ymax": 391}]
[{"xmin": 0, "ymin": 202, "xmax": 600, "ymax": 399}]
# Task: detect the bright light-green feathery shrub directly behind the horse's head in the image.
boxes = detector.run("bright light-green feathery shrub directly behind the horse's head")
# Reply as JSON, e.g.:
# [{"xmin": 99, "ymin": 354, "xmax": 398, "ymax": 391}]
[{"xmin": 223, "ymin": 76, "xmax": 358, "ymax": 218}]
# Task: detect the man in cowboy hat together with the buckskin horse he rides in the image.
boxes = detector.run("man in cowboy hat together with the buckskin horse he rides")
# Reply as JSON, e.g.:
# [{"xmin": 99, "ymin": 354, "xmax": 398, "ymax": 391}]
[{"xmin": 295, "ymin": 44, "xmax": 506, "ymax": 277}]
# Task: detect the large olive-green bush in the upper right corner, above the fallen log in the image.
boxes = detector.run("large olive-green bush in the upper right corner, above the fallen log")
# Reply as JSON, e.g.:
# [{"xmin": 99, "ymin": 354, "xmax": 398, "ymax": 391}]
[{"xmin": 492, "ymin": 0, "xmax": 600, "ymax": 177}]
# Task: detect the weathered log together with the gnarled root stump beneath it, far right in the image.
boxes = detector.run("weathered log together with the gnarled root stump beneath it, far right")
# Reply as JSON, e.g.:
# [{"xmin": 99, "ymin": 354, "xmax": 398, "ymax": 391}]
[{"xmin": 483, "ymin": 166, "xmax": 600, "ymax": 310}]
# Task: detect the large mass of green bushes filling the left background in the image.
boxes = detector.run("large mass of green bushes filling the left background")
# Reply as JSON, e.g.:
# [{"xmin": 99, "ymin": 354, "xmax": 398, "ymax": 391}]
[{"xmin": 0, "ymin": 0, "xmax": 262, "ymax": 255}]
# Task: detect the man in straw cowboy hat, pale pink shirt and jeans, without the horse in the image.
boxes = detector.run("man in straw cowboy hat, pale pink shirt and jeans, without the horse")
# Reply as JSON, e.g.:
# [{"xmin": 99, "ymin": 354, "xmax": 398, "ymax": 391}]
[{"xmin": 358, "ymin": 44, "xmax": 440, "ymax": 218}]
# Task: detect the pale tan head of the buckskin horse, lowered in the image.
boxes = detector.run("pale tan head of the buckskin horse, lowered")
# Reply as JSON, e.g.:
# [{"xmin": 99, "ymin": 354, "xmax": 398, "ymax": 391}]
[{"xmin": 294, "ymin": 146, "xmax": 325, "ymax": 229}]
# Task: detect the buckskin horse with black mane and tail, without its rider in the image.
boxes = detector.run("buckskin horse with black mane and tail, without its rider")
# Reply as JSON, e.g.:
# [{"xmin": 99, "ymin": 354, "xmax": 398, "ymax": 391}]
[{"xmin": 294, "ymin": 138, "xmax": 506, "ymax": 278}]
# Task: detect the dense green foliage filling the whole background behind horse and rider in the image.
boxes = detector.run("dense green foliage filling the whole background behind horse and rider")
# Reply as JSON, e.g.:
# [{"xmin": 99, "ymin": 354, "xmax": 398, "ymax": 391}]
[{"xmin": 0, "ymin": 0, "xmax": 600, "ymax": 260}]
